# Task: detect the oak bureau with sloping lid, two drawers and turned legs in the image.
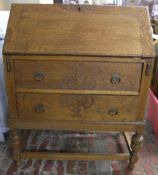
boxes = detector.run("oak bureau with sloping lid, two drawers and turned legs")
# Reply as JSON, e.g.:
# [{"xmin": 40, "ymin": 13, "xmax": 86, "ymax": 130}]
[{"xmin": 3, "ymin": 4, "xmax": 154, "ymax": 169}]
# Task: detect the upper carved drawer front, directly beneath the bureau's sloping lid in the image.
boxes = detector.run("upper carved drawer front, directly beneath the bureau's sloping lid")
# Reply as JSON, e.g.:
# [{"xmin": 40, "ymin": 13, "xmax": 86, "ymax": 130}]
[{"xmin": 14, "ymin": 60, "xmax": 142, "ymax": 91}]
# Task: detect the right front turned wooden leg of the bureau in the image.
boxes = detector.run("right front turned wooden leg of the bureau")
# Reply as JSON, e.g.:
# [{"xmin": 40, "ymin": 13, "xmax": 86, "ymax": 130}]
[{"xmin": 129, "ymin": 133, "xmax": 143, "ymax": 170}]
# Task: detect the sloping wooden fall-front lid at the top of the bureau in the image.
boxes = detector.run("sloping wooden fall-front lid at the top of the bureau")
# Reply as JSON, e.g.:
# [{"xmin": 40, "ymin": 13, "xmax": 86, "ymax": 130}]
[{"xmin": 3, "ymin": 4, "xmax": 154, "ymax": 58}]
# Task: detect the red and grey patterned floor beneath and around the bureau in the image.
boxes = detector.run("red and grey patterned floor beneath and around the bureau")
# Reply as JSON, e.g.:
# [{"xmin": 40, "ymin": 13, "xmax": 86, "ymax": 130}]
[{"xmin": 0, "ymin": 118, "xmax": 158, "ymax": 175}]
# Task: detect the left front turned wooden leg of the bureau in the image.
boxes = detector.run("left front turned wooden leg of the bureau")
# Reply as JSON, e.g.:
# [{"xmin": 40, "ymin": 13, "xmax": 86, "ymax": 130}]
[{"xmin": 10, "ymin": 129, "xmax": 21, "ymax": 166}]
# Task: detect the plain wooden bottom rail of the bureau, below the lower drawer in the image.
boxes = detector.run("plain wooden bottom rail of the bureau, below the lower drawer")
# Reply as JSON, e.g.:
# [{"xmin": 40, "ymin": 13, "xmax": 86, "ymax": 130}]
[{"xmin": 8, "ymin": 118, "xmax": 145, "ymax": 132}]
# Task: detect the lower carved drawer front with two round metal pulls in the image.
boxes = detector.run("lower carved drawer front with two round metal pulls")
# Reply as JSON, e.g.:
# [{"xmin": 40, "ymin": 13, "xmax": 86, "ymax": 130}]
[{"xmin": 17, "ymin": 93, "xmax": 139, "ymax": 121}]
